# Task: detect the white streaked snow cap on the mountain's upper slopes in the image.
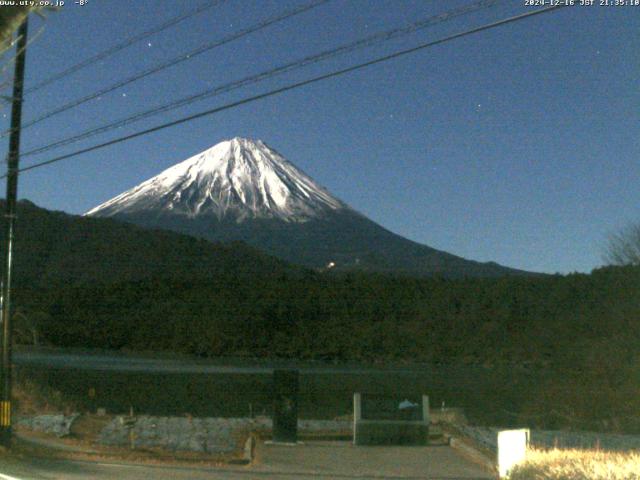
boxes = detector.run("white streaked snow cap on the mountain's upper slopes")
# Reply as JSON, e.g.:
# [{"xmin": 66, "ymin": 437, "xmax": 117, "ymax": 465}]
[{"xmin": 86, "ymin": 137, "xmax": 349, "ymax": 223}]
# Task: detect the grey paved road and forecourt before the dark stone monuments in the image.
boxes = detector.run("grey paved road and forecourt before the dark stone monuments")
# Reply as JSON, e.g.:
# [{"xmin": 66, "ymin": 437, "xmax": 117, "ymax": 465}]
[{"xmin": 0, "ymin": 442, "xmax": 495, "ymax": 480}]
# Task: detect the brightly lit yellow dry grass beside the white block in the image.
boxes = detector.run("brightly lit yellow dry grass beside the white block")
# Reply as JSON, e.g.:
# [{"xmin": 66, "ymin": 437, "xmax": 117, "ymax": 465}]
[{"xmin": 509, "ymin": 449, "xmax": 640, "ymax": 480}]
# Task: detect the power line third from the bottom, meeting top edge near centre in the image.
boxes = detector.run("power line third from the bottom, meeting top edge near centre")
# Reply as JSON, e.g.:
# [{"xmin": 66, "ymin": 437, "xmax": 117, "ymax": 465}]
[{"xmin": 0, "ymin": 0, "xmax": 331, "ymax": 138}]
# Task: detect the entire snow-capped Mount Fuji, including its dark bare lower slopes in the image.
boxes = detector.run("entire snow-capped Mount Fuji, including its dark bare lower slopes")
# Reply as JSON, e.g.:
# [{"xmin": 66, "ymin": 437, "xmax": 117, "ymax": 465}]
[{"xmin": 85, "ymin": 138, "xmax": 528, "ymax": 277}]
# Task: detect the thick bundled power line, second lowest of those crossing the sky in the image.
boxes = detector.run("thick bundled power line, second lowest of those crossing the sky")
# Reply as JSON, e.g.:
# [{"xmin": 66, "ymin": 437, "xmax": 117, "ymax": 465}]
[{"xmin": 22, "ymin": 0, "xmax": 502, "ymax": 157}]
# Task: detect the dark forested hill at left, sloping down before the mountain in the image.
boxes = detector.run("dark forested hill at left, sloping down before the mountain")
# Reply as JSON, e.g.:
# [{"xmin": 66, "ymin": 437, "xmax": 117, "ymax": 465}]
[{"xmin": 0, "ymin": 201, "xmax": 302, "ymax": 288}]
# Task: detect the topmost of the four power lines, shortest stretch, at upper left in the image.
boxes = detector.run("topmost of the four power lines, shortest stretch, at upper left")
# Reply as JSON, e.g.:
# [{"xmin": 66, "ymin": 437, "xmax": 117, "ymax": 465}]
[{"xmin": 20, "ymin": 0, "xmax": 226, "ymax": 94}]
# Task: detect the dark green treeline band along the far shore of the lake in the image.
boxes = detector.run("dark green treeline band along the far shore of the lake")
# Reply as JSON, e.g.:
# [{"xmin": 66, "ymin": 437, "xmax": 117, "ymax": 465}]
[{"xmin": 16, "ymin": 268, "xmax": 640, "ymax": 365}]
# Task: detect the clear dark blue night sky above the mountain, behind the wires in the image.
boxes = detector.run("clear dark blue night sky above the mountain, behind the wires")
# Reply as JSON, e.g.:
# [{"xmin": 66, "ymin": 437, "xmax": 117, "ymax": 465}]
[{"xmin": 2, "ymin": 0, "xmax": 640, "ymax": 273}]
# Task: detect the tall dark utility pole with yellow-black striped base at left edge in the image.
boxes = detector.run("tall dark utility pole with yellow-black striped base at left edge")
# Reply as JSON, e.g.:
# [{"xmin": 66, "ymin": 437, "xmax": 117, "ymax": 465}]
[{"xmin": 0, "ymin": 17, "xmax": 28, "ymax": 448}]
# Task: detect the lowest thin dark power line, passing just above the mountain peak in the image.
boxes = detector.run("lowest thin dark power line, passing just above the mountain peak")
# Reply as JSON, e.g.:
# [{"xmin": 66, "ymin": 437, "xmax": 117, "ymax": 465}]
[{"xmin": 5, "ymin": 4, "xmax": 566, "ymax": 179}]
